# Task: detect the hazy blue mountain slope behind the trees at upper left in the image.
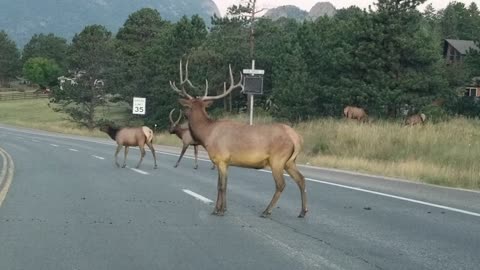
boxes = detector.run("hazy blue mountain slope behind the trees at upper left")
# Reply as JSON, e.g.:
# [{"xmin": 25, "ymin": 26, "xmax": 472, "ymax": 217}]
[{"xmin": 0, "ymin": 0, "xmax": 220, "ymax": 48}]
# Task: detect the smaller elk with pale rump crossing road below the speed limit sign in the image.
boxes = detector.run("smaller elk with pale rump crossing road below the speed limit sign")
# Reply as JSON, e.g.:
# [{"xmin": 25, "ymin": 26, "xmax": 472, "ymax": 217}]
[{"xmin": 100, "ymin": 125, "xmax": 157, "ymax": 169}]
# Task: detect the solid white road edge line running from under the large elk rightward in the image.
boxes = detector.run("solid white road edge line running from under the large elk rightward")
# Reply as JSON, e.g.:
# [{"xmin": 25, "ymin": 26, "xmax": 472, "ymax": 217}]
[{"xmin": 258, "ymin": 170, "xmax": 480, "ymax": 217}]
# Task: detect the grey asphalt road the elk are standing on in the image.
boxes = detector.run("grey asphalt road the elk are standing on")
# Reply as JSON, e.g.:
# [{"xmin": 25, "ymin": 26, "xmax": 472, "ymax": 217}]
[{"xmin": 0, "ymin": 125, "xmax": 480, "ymax": 270}]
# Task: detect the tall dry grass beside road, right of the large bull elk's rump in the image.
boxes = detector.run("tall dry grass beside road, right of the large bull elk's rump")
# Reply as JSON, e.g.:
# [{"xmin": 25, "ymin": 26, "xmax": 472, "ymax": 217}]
[{"xmin": 296, "ymin": 118, "xmax": 480, "ymax": 189}]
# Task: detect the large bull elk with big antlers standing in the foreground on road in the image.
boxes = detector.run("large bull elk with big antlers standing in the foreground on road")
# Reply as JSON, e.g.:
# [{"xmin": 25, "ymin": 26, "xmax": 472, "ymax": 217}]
[{"xmin": 170, "ymin": 61, "xmax": 307, "ymax": 217}]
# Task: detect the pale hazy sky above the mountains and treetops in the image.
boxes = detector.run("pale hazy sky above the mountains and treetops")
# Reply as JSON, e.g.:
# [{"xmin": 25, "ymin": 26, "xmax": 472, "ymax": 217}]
[{"xmin": 213, "ymin": 0, "xmax": 480, "ymax": 15}]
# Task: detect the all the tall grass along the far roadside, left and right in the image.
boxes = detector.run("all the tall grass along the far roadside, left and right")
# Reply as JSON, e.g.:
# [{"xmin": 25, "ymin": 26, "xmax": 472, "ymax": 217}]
[{"xmin": 0, "ymin": 99, "xmax": 480, "ymax": 190}]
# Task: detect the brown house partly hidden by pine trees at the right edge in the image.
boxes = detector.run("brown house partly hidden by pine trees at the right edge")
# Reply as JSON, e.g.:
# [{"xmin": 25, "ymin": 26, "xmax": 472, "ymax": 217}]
[{"xmin": 443, "ymin": 39, "xmax": 480, "ymax": 97}]
